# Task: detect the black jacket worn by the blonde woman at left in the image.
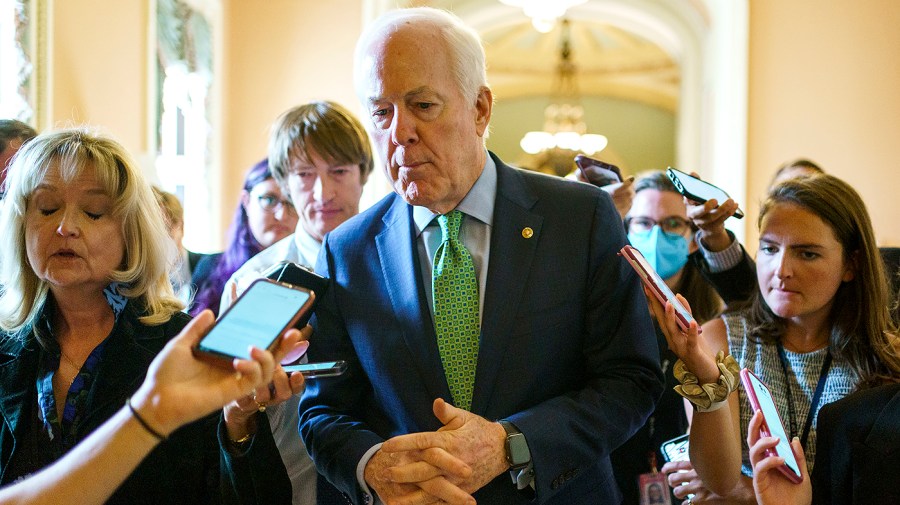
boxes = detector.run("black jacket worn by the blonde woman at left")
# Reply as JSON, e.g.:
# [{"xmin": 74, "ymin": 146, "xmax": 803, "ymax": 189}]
[{"xmin": 0, "ymin": 302, "xmax": 221, "ymax": 504}]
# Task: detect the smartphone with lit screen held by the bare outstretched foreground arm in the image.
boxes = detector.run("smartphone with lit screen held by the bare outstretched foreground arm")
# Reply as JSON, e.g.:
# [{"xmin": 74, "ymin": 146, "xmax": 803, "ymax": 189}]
[{"xmin": 193, "ymin": 279, "xmax": 315, "ymax": 367}]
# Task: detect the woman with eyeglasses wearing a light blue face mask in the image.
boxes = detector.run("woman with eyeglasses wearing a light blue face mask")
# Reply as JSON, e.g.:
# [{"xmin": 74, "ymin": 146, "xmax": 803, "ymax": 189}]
[{"xmin": 612, "ymin": 171, "xmax": 723, "ymax": 504}]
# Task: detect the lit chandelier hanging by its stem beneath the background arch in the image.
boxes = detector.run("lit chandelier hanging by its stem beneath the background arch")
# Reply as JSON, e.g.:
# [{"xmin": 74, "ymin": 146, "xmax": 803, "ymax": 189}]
[{"xmin": 519, "ymin": 19, "xmax": 608, "ymax": 155}]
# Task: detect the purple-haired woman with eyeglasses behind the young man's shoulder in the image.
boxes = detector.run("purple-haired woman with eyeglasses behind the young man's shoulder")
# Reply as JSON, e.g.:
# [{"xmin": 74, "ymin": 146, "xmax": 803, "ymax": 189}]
[{"xmin": 190, "ymin": 159, "xmax": 299, "ymax": 316}]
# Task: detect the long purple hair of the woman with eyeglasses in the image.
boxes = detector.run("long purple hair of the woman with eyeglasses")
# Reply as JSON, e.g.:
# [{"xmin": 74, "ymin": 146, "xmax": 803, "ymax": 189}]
[{"xmin": 190, "ymin": 159, "xmax": 272, "ymax": 316}]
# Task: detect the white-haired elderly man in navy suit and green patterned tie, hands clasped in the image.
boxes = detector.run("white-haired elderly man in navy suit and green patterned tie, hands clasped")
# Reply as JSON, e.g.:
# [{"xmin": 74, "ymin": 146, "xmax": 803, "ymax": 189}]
[{"xmin": 300, "ymin": 8, "xmax": 662, "ymax": 504}]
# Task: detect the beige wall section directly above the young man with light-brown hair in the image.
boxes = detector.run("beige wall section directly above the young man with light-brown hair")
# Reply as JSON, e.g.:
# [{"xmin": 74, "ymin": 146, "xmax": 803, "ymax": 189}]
[{"xmin": 222, "ymin": 0, "xmax": 362, "ymax": 237}]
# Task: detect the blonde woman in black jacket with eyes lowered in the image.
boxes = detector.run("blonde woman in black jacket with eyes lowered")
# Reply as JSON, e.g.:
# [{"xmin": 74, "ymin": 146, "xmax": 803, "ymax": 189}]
[{"xmin": 0, "ymin": 129, "xmax": 219, "ymax": 503}]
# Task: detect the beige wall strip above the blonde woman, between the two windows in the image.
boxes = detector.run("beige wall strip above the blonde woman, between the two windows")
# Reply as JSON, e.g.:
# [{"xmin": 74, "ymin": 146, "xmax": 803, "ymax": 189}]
[{"xmin": 48, "ymin": 0, "xmax": 147, "ymax": 156}]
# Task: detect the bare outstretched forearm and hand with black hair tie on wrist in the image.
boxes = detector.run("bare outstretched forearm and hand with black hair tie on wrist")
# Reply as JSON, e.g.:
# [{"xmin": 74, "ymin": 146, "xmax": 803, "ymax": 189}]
[{"xmin": 0, "ymin": 310, "xmax": 300, "ymax": 505}]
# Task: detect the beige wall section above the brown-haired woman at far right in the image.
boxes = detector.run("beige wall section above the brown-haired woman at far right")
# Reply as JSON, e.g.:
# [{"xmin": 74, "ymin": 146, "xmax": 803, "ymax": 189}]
[{"xmin": 746, "ymin": 0, "xmax": 900, "ymax": 250}]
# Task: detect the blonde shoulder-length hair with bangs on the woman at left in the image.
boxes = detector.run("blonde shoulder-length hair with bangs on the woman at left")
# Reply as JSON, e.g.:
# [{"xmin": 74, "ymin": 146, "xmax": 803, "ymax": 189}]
[{"xmin": 0, "ymin": 128, "xmax": 183, "ymax": 332}]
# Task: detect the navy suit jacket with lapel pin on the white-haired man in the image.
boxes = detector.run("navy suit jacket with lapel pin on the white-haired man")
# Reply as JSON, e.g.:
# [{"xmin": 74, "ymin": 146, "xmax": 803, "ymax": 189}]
[{"xmin": 300, "ymin": 155, "xmax": 662, "ymax": 504}]
